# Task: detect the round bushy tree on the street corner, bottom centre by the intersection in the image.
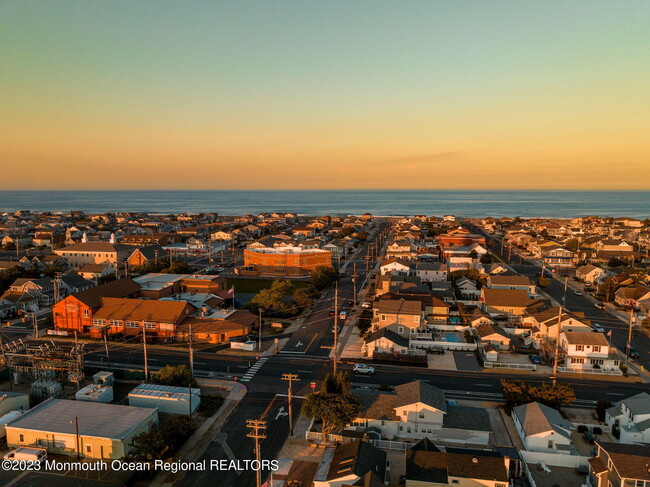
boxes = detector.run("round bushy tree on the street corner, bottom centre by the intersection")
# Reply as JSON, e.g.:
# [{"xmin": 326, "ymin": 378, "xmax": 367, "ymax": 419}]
[{"xmin": 302, "ymin": 392, "xmax": 361, "ymax": 441}]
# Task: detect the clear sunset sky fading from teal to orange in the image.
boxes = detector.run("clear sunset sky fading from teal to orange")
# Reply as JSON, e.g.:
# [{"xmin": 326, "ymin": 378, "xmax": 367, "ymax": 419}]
[{"xmin": 0, "ymin": 0, "xmax": 650, "ymax": 190}]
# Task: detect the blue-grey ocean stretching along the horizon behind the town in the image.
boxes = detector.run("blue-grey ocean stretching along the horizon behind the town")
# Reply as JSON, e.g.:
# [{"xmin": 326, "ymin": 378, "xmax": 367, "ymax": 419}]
[{"xmin": 0, "ymin": 190, "xmax": 650, "ymax": 219}]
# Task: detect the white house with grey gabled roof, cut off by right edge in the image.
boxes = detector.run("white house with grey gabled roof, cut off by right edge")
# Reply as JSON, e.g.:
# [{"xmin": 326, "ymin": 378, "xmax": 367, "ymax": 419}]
[{"xmin": 605, "ymin": 392, "xmax": 650, "ymax": 444}]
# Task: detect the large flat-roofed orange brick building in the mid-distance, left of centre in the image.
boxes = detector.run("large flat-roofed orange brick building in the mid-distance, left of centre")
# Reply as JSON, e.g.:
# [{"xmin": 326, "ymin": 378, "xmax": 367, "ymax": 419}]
[{"xmin": 240, "ymin": 247, "xmax": 332, "ymax": 277}]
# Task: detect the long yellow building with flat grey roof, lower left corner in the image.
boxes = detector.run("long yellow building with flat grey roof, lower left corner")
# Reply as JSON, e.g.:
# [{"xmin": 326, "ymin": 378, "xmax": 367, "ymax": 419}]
[{"xmin": 6, "ymin": 398, "xmax": 158, "ymax": 460}]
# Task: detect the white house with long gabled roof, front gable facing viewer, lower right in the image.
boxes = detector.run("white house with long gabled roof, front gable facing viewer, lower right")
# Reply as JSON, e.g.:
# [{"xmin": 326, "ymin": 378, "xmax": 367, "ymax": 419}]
[{"xmin": 512, "ymin": 402, "xmax": 573, "ymax": 455}]
